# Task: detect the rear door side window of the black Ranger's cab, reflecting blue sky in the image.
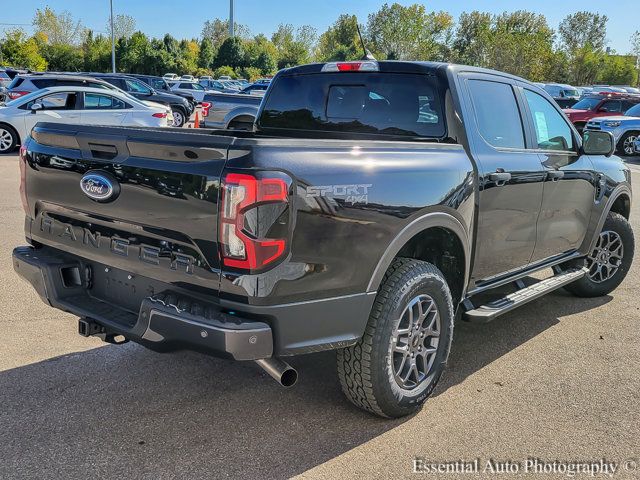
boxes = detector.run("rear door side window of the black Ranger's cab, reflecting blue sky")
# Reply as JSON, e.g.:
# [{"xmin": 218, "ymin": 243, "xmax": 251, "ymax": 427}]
[{"xmin": 469, "ymin": 80, "xmax": 524, "ymax": 148}]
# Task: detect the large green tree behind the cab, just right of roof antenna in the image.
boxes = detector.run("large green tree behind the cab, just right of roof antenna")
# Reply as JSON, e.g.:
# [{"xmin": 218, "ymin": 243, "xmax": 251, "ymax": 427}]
[{"xmin": 367, "ymin": 3, "xmax": 454, "ymax": 60}]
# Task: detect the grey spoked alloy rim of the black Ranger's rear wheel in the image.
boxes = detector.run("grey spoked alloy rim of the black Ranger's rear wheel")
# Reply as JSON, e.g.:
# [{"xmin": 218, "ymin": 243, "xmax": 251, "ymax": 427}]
[{"xmin": 391, "ymin": 295, "xmax": 440, "ymax": 390}]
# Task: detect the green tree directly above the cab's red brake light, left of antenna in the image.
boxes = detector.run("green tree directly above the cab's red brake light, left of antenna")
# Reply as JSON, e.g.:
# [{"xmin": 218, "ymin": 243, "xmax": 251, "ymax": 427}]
[{"xmin": 316, "ymin": 14, "xmax": 364, "ymax": 61}]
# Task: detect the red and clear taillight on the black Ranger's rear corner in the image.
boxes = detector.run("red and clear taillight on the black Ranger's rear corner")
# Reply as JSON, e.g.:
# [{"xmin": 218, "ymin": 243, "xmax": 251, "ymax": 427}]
[{"xmin": 218, "ymin": 172, "xmax": 290, "ymax": 270}]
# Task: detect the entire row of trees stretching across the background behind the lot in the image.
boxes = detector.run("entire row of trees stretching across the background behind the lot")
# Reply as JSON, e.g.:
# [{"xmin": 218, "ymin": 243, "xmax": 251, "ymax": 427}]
[{"xmin": 0, "ymin": 3, "xmax": 640, "ymax": 85}]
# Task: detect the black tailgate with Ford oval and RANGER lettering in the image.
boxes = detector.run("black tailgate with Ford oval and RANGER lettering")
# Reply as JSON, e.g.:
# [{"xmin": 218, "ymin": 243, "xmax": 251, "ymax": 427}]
[{"xmin": 25, "ymin": 123, "xmax": 233, "ymax": 294}]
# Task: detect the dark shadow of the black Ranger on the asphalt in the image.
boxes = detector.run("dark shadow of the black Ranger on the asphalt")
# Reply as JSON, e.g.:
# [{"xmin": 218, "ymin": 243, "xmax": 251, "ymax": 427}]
[{"xmin": 0, "ymin": 293, "xmax": 611, "ymax": 479}]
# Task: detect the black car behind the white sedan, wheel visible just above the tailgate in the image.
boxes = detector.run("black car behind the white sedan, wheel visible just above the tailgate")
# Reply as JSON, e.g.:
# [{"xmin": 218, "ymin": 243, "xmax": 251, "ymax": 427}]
[{"xmin": 92, "ymin": 73, "xmax": 193, "ymax": 127}]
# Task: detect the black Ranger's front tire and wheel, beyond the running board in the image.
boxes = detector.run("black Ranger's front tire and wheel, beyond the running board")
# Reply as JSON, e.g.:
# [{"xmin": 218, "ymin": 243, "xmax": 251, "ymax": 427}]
[{"xmin": 564, "ymin": 212, "xmax": 635, "ymax": 297}]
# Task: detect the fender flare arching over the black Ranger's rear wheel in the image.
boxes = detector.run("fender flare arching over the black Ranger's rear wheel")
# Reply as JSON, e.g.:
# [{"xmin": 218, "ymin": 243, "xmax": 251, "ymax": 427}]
[{"xmin": 367, "ymin": 212, "xmax": 471, "ymax": 293}]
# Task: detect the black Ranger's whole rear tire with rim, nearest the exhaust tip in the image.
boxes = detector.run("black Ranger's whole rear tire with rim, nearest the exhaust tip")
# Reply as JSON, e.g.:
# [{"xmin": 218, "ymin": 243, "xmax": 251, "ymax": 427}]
[{"xmin": 337, "ymin": 258, "xmax": 454, "ymax": 417}]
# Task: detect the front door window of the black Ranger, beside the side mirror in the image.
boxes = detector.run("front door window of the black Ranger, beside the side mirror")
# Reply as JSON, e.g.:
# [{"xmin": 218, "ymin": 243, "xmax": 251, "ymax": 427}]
[{"xmin": 524, "ymin": 90, "xmax": 573, "ymax": 150}]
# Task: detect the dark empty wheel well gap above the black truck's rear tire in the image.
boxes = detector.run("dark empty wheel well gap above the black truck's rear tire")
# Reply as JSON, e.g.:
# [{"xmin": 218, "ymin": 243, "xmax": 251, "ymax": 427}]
[{"xmin": 397, "ymin": 227, "xmax": 466, "ymax": 305}]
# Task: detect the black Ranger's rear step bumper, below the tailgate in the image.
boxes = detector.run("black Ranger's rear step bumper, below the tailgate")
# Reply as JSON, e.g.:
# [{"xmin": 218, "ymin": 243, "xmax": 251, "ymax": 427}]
[{"xmin": 13, "ymin": 247, "xmax": 273, "ymax": 360}]
